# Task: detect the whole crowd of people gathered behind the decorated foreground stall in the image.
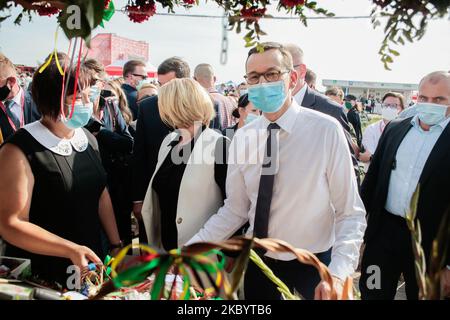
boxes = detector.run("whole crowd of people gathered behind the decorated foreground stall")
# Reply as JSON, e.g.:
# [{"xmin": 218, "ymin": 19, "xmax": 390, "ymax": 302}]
[{"xmin": 0, "ymin": 42, "xmax": 450, "ymax": 300}]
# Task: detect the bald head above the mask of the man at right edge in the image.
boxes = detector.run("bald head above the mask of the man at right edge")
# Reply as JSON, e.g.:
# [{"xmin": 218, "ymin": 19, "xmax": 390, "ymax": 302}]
[{"xmin": 418, "ymin": 71, "xmax": 450, "ymax": 106}]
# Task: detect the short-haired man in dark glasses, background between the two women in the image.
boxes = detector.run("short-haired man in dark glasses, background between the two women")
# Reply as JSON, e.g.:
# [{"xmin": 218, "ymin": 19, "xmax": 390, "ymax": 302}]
[{"xmin": 122, "ymin": 60, "xmax": 148, "ymax": 120}]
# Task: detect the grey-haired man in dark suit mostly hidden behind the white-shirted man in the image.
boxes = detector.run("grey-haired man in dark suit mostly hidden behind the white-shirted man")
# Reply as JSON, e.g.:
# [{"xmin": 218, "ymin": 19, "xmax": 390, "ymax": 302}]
[{"xmin": 285, "ymin": 44, "xmax": 359, "ymax": 181}]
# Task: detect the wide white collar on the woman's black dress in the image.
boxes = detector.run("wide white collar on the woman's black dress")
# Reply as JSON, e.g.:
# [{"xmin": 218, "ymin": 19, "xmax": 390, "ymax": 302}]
[{"xmin": 23, "ymin": 121, "xmax": 89, "ymax": 156}]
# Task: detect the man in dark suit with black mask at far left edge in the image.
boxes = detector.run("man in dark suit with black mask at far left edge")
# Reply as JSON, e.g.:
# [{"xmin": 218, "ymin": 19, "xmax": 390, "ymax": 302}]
[{"xmin": 0, "ymin": 53, "xmax": 41, "ymax": 140}]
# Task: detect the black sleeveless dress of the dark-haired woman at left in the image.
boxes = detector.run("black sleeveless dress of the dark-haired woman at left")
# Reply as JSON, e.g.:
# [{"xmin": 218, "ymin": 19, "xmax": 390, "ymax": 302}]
[{"xmin": 5, "ymin": 125, "xmax": 106, "ymax": 287}]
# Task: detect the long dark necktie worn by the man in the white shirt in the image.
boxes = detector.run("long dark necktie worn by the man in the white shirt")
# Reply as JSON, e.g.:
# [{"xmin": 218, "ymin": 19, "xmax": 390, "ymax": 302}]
[{"xmin": 253, "ymin": 123, "xmax": 280, "ymax": 239}]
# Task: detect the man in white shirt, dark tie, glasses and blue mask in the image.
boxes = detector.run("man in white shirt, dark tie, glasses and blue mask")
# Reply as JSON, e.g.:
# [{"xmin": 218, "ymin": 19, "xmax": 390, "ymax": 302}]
[{"xmin": 188, "ymin": 43, "xmax": 366, "ymax": 299}]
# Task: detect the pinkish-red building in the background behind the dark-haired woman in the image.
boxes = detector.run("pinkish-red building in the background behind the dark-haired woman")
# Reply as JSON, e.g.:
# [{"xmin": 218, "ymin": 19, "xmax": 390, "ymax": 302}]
[{"xmin": 87, "ymin": 33, "xmax": 149, "ymax": 66}]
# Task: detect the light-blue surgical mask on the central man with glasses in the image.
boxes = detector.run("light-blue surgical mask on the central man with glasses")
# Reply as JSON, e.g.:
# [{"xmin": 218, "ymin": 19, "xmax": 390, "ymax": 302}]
[{"xmin": 248, "ymin": 80, "xmax": 286, "ymax": 113}]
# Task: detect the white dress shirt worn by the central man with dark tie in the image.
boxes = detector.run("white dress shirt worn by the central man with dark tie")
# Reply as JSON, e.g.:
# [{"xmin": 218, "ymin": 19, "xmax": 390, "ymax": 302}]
[{"xmin": 188, "ymin": 101, "xmax": 366, "ymax": 279}]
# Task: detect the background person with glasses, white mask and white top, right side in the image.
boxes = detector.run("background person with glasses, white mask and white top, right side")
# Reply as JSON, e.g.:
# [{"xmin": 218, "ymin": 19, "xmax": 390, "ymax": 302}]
[{"xmin": 359, "ymin": 92, "xmax": 405, "ymax": 163}]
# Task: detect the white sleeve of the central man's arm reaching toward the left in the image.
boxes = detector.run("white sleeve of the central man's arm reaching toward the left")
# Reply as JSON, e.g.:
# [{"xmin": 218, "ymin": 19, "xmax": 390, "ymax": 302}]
[{"xmin": 186, "ymin": 137, "xmax": 250, "ymax": 245}]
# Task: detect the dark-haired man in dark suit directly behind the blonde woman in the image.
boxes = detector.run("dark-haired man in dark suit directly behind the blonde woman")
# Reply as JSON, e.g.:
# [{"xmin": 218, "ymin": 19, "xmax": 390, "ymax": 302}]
[{"xmin": 132, "ymin": 57, "xmax": 190, "ymax": 226}]
